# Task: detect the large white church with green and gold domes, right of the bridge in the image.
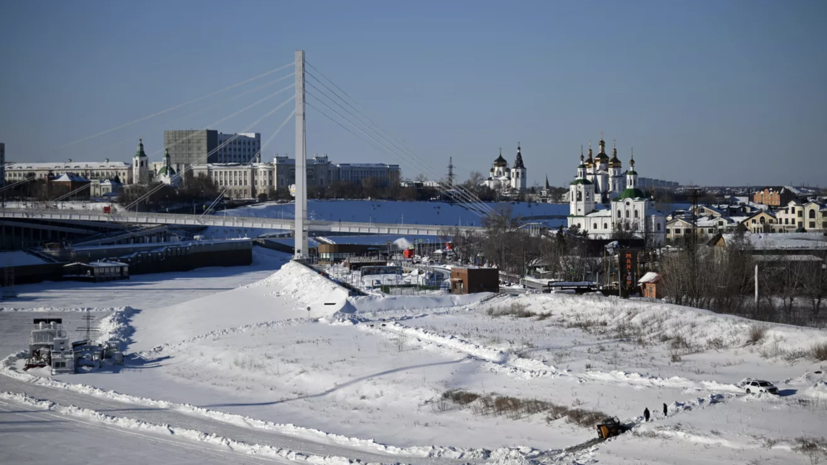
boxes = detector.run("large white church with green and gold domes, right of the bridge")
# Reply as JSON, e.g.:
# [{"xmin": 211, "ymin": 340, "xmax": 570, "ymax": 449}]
[{"xmin": 568, "ymin": 140, "xmax": 666, "ymax": 247}]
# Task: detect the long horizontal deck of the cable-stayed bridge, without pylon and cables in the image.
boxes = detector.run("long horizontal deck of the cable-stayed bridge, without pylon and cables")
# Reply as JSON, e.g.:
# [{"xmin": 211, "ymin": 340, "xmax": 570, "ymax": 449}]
[{"xmin": 0, "ymin": 208, "xmax": 483, "ymax": 236}]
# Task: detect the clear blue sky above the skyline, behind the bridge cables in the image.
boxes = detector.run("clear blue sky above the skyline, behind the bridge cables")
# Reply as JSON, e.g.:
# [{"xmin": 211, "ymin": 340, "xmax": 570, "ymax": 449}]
[{"xmin": 0, "ymin": 0, "xmax": 827, "ymax": 186}]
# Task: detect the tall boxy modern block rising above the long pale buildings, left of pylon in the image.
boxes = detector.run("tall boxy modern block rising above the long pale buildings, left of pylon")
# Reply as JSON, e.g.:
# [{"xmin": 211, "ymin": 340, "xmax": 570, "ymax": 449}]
[{"xmin": 164, "ymin": 129, "xmax": 261, "ymax": 173}]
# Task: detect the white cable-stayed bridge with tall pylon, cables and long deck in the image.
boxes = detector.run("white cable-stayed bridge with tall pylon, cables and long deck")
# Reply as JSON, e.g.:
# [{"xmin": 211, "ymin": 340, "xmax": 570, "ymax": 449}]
[{"xmin": 0, "ymin": 50, "xmax": 494, "ymax": 250}]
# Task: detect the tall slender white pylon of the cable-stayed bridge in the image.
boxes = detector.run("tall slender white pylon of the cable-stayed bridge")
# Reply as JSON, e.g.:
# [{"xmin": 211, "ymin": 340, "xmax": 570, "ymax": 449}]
[{"xmin": 293, "ymin": 50, "xmax": 308, "ymax": 260}]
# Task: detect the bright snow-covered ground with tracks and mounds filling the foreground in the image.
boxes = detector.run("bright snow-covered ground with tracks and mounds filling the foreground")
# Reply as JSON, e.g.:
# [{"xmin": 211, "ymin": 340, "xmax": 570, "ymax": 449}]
[{"xmin": 0, "ymin": 254, "xmax": 827, "ymax": 465}]
